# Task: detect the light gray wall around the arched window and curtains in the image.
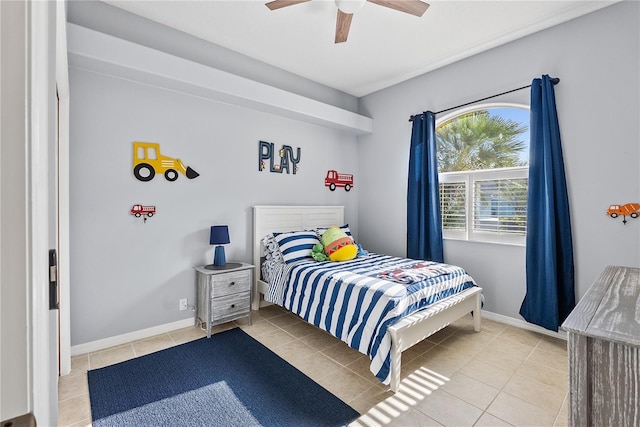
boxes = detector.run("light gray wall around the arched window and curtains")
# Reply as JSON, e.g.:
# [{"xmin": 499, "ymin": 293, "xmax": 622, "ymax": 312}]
[{"xmin": 358, "ymin": 2, "xmax": 640, "ymax": 318}]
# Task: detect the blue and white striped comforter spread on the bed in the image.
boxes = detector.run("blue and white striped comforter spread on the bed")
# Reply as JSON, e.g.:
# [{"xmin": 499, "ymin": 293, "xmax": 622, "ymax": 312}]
[{"xmin": 266, "ymin": 254, "xmax": 475, "ymax": 384}]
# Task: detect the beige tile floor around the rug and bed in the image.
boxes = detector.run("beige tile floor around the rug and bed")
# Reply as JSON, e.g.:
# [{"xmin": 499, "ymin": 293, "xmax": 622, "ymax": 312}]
[{"xmin": 58, "ymin": 306, "xmax": 568, "ymax": 427}]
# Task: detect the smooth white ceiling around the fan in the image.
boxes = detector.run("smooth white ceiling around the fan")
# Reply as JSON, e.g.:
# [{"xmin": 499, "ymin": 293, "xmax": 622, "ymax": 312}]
[{"xmin": 105, "ymin": 0, "xmax": 616, "ymax": 97}]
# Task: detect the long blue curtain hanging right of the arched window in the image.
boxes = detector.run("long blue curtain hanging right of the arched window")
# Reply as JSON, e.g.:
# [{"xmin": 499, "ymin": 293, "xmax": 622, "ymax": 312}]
[{"xmin": 520, "ymin": 75, "xmax": 575, "ymax": 331}]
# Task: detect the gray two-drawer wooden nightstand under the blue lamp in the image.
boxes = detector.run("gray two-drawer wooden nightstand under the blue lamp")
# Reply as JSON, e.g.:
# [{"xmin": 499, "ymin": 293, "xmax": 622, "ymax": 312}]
[{"xmin": 195, "ymin": 262, "xmax": 253, "ymax": 338}]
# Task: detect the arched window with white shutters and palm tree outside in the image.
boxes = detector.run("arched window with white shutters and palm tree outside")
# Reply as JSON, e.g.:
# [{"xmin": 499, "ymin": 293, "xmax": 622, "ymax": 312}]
[{"xmin": 436, "ymin": 104, "xmax": 529, "ymax": 244}]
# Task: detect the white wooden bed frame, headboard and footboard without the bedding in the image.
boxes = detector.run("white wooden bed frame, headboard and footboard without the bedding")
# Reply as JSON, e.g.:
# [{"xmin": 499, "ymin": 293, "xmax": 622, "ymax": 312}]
[{"xmin": 252, "ymin": 206, "xmax": 482, "ymax": 393}]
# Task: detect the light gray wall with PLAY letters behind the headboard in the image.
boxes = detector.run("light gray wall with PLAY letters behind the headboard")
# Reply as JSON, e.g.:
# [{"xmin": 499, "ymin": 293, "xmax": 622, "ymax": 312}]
[{"xmin": 70, "ymin": 68, "xmax": 359, "ymax": 345}]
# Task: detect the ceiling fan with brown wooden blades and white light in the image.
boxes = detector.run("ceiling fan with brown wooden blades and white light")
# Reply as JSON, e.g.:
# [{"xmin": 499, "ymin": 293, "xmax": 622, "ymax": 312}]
[{"xmin": 266, "ymin": 0, "xmax": 429, "ymax": 43}]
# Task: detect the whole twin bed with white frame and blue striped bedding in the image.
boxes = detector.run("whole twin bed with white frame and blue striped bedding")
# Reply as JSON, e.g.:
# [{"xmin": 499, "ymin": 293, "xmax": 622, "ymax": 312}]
[{"xmin": 252, "ymin": 206, "xmax": 482, "ymax": 392}]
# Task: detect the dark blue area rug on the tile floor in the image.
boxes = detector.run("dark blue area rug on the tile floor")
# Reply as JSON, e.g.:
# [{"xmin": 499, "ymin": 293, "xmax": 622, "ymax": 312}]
[{"xmin": 88, "ymin": 328, "xmax": 359, "ymax": 427}]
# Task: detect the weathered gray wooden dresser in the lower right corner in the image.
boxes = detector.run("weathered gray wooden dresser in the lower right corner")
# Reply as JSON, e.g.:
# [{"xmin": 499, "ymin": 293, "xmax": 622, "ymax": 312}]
[{"xmin": 562, "ymin": 266, "xmax": 640, "ymax": 427}]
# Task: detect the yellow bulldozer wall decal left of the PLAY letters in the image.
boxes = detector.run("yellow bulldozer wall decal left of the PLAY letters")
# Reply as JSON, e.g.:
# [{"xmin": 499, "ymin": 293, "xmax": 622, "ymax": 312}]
[{"xmin": 133, "ymin": 141, "xmax": 200, "ymax": 182}]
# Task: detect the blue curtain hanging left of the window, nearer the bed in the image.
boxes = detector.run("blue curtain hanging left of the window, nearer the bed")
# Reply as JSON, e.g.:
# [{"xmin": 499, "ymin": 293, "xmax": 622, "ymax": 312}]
[{"xmin": 407, "ymin": 111, "xmax": 444, "ymax": 262}]
